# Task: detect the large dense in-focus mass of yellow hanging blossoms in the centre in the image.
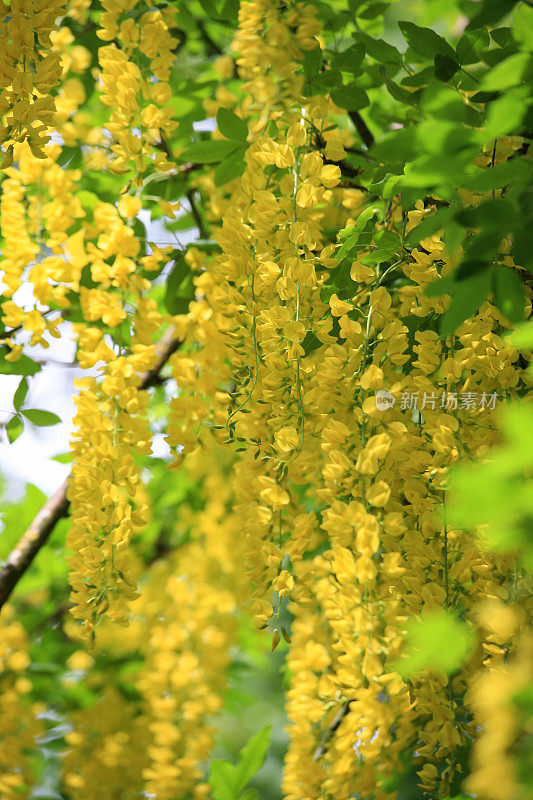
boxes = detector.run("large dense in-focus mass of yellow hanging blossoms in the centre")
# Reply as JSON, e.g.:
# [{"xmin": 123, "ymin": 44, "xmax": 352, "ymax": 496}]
[{"xmin": 164, "ymin": 2, "xmax": 524, "ymax": 800}]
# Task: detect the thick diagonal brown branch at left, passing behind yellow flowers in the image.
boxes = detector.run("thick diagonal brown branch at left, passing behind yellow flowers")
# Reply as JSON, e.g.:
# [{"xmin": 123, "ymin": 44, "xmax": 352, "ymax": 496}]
[{"xmin": 0, "ymin": 328, "xmax": 181, "ymax": 608}]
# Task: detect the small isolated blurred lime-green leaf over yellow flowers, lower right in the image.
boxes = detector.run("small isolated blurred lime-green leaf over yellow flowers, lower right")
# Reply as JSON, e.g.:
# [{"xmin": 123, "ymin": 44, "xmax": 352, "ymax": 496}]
[{"xmin": 396, "ymin": 609, "xmax": 473, "ymax": 678}]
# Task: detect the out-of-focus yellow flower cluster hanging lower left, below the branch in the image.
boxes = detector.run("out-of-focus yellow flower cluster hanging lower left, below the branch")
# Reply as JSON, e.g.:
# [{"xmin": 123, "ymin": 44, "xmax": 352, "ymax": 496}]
[{"xmin": 63, "ymin": 442, "xmax": 245, "ymax": 800}]
